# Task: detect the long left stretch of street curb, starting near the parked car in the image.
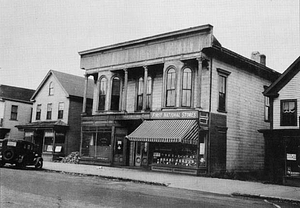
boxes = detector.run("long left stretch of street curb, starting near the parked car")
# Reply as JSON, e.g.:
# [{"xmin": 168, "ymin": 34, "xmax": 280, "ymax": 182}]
[{"xmin": 43, "ymin": 169, "xmax": 168, "ymax": 187}]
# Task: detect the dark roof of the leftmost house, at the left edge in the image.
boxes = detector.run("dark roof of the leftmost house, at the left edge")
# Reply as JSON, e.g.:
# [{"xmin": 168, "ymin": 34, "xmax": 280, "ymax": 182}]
[{"xmin": 0, "ymin": 85, "xmax": 35, "ymax": 102}]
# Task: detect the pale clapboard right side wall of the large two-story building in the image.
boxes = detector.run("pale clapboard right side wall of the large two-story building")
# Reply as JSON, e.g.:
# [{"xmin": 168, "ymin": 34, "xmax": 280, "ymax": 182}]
[{"xmin": 212, "ymin": 59, "xmax": 271, "ymax": 171}]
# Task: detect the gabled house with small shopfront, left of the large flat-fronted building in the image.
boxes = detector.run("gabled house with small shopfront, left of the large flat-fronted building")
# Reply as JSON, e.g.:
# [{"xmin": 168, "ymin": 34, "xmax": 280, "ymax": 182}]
[{"xmin": 17, "ymin": 70, "xmax": 92, "ymax": 160}]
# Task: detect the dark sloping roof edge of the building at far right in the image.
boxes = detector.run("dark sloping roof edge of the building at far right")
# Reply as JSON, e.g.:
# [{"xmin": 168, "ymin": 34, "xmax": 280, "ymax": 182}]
[{"xmin": 264, "ymin": 56, "xmax": 300, "ymax": 97}]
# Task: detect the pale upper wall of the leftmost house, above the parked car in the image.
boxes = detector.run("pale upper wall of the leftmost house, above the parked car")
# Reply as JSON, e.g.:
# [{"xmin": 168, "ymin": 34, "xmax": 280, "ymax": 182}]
[{"xmin": 3, "ymin": 100, "xmax": 32, "ymax": 139}]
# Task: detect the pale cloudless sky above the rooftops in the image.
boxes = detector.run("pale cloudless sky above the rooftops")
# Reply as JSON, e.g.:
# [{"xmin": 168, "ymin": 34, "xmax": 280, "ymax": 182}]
[{"xmin": 0, "ymin": 0, "xmax": 300, "ymax": 89}]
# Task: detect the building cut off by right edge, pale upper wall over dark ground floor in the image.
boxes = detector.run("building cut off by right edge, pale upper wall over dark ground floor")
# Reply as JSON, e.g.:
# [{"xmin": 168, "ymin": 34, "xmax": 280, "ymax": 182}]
[{"xmin": 259, "ymin": 57, "xmax": 300, "ymax": 186}]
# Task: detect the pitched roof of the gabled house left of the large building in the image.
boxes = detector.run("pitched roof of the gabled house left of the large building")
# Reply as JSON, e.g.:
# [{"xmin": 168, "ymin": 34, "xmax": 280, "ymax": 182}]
[{"xmin": 31, "ymin": 70, "xmax": 93, "ymax": 99}]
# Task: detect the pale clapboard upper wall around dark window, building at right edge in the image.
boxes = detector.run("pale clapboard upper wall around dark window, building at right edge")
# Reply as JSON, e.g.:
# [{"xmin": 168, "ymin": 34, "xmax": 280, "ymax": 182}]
[{"xmin": 273, "ymin": 73, "xmax": 300, "ymax": 129}]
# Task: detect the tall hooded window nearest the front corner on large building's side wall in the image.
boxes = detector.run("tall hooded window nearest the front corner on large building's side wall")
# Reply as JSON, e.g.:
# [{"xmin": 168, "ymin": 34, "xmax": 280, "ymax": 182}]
[{"xmin": 217, "ymin": 68, "xmax": 231, "ymax": 113}]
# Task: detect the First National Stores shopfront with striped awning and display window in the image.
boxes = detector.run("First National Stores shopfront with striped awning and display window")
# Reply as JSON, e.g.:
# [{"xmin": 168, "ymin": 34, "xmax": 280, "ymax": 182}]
[{"xmin": 127, "ymin": 111, "xmax": 208, "ymax": 175}]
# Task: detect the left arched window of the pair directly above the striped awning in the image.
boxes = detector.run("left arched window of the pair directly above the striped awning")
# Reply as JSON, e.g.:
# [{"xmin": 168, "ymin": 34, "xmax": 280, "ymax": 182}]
[{"xmin": 165, "ymin": 66, "xmax": 177, "ymax": 108}]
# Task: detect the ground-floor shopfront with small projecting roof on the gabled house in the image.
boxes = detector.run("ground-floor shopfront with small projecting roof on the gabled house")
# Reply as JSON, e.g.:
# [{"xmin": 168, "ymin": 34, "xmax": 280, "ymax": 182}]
[{"xmin": 17, "ymin": 121, "xmax": 69, "ymax": 161}]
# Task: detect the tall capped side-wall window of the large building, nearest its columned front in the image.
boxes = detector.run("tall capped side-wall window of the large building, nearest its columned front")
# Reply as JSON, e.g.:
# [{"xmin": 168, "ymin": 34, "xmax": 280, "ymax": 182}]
[{"xmin": 217, "ymin": 69, "xmax": 230, "ymax": 112}]
